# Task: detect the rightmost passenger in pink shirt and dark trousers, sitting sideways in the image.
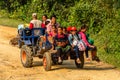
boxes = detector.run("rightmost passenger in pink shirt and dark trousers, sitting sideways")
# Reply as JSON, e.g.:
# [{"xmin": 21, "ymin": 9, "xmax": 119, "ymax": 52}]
[{"xmin": 79, "ymin": 25, "xmax": 100, "ymax": 62}]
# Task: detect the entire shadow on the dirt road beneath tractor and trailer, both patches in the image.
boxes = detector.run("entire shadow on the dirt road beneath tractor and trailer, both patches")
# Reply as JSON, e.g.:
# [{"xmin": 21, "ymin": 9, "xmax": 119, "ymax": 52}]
[{"xmin": 33, "ymin": 61, "xmax": 116, "ymax": 71}]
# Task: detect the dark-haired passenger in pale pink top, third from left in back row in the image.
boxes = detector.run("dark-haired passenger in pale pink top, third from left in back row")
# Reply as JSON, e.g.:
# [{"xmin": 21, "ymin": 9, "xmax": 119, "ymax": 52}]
[{"xmin": 46, "ymin": 15, "xmax": 60, "ymax": 34}]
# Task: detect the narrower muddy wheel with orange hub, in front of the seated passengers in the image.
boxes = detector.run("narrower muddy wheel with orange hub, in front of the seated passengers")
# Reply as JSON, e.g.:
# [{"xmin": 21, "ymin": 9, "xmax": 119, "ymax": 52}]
[{"xmin": 43, "ymin": 52, "xmax": 52, "ymax": 71}]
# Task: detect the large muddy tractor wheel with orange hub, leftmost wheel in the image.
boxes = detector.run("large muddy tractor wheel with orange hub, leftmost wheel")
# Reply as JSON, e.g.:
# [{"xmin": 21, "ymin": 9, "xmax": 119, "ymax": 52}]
[{"xmin": 20, "ymin": 45, "xmax": 33, "ymax": 68}]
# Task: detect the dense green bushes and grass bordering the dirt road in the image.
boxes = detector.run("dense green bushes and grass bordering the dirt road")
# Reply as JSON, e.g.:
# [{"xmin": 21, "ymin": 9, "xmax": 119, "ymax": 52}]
[{"xmin": 0, "ymin": 0, "xmax": 120, "ymax": 67}]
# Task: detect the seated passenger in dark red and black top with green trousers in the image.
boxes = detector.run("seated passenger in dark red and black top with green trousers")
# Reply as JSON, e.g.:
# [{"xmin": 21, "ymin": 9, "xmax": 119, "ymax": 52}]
[{"xmin": 55, "ymin": 27, "xmax": 71, "ymax": 63}]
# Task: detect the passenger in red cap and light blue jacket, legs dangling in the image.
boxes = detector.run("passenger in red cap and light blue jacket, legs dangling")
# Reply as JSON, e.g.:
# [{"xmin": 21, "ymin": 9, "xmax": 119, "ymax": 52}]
[{"xmin": 68, "ymin": 27, "xmax": 81, "ymax": 63}]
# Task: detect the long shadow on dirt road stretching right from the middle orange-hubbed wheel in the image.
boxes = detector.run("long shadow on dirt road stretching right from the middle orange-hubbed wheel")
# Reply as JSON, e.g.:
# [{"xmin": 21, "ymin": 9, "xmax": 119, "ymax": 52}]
[{"xmin": 52, "ymin": 63, "xmax": 116, "ymax": 71}]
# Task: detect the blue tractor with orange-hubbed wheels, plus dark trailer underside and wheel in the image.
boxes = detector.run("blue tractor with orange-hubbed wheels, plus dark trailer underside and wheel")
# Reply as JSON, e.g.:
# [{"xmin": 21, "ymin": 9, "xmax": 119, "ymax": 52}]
[{"xmin": 18, "ymin": 28, "xmax": 84, "ymax": 71}]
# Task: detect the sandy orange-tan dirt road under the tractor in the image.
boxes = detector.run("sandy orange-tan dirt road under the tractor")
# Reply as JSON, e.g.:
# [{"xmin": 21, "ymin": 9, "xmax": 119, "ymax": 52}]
[{"xmin": 0, "ymin": 26, "xmax": 120, "ymax": 80}]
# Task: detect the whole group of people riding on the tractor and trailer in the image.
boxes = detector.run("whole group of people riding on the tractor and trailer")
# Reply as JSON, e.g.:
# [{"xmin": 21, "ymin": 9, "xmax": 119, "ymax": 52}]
[{"xmin": 29, "ymin": 13, "xmax": 100, "ymax": 63}]
